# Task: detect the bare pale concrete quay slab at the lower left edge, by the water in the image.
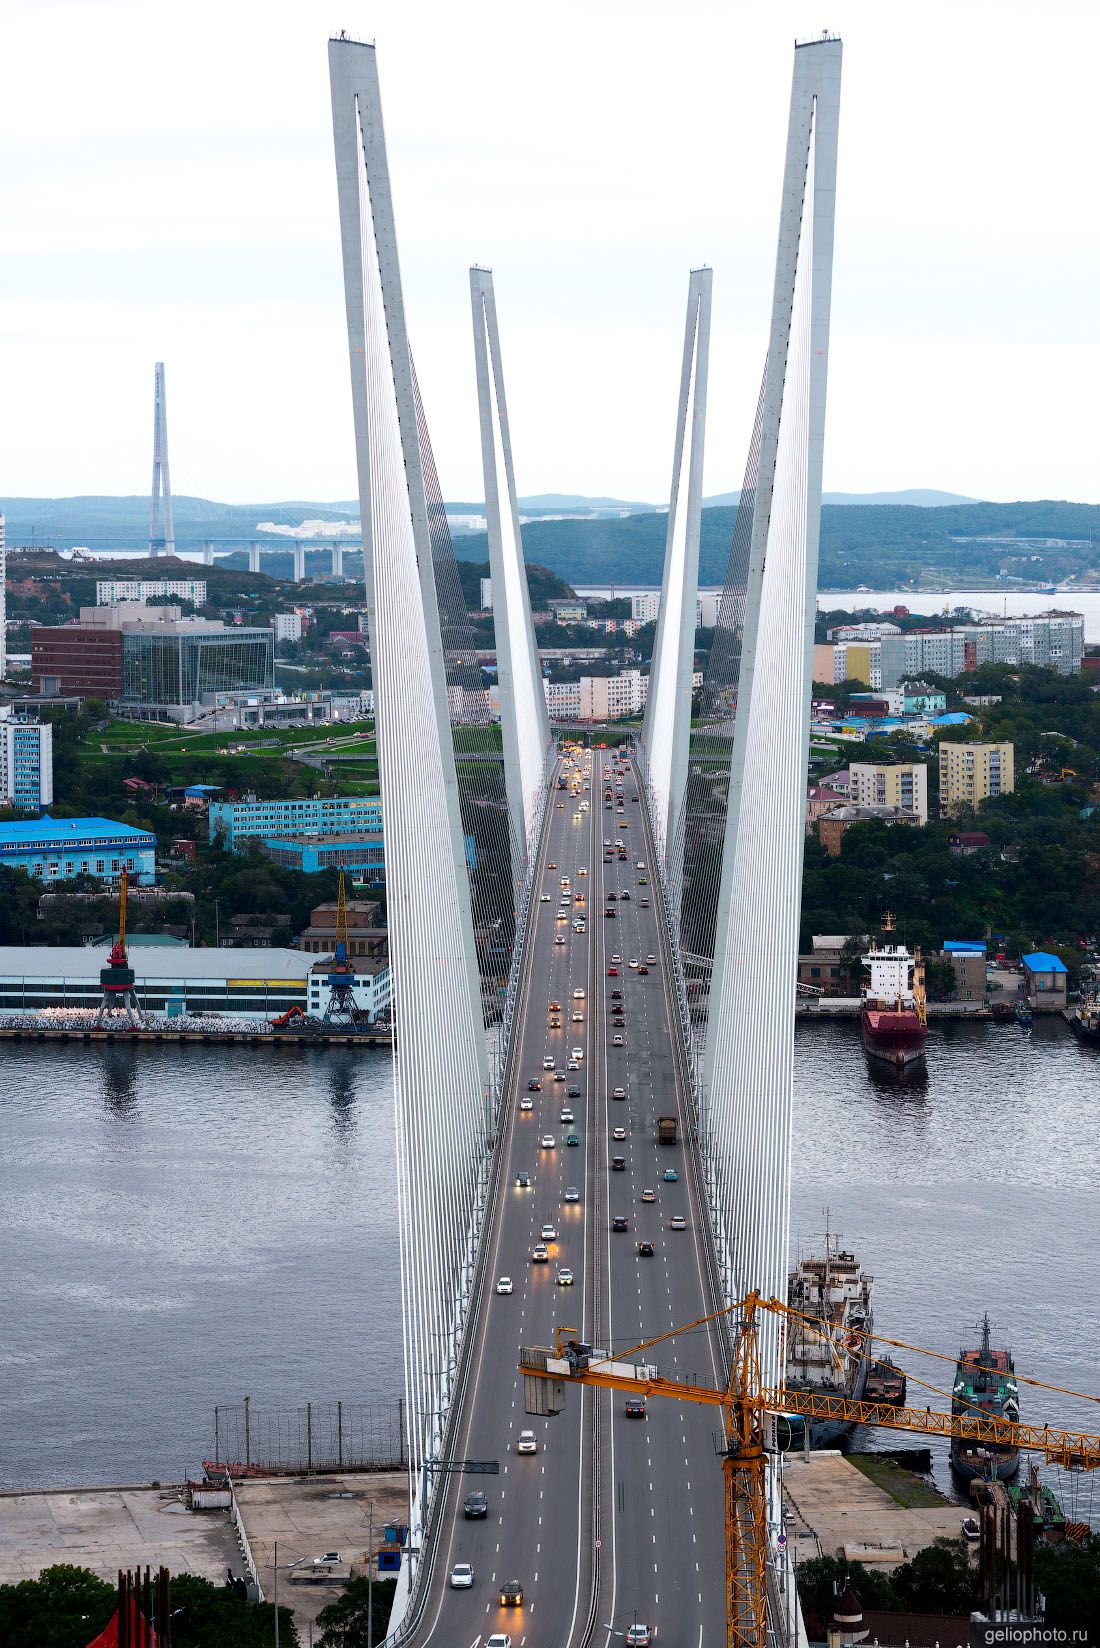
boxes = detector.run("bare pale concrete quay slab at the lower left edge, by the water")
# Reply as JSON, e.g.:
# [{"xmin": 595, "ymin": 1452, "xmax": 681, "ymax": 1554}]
[{"xmin": 0, "ymin": 1488, "xmax": 241, "ymax": 1584}]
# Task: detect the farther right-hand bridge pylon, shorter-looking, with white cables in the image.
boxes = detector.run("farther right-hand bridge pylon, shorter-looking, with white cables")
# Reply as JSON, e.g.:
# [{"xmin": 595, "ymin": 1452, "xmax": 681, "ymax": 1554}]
[{"xmin": 640, "ymin": 269, "xmax": 712, "ymax": 911}]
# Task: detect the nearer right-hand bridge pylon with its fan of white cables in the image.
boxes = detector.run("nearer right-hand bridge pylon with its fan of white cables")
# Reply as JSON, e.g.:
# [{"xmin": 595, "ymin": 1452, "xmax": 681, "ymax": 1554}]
[{"xmin": 701, "ymin": 36, "xmax": 841, "ymax": 1384}]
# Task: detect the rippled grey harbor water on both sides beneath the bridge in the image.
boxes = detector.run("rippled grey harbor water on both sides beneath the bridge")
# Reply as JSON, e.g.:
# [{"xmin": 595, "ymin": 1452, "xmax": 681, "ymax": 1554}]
[{"xmin": 0, "ymin": 1020, "xmax": 1100, "ymax": 1515}]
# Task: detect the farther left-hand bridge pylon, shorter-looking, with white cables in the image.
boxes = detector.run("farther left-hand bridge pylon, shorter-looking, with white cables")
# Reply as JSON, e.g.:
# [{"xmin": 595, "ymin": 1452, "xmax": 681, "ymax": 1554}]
[{"xmin": 470, "ymin": 269, "xmax": 551, "ymax": 888}]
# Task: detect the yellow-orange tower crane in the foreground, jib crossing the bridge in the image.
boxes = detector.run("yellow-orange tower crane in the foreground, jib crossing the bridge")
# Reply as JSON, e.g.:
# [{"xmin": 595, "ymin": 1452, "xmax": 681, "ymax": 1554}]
[{"xmin": 519, "ymin": 1292, "xmax": 1100, "ymax": 1648}]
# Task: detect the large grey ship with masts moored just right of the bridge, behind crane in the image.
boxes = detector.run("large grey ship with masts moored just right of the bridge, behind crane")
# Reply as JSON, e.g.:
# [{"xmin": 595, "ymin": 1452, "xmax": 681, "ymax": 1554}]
[{"xmin": 780, "ymin": 1229, "xmax": 874, "ymax": 1449}]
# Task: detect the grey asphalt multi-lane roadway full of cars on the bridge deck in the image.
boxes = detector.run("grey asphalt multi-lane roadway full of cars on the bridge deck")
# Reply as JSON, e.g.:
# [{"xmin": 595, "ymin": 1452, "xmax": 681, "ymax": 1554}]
[{"xmin": 408, "ymin": 750, "xmax": 724, "ymax": 1648}]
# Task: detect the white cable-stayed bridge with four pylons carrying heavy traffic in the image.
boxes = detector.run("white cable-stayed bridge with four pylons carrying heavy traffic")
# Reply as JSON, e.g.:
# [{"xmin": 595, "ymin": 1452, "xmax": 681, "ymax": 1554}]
[{"xmin": 330, "ymin": 38, "xmax": 841, "ymax": 1648}]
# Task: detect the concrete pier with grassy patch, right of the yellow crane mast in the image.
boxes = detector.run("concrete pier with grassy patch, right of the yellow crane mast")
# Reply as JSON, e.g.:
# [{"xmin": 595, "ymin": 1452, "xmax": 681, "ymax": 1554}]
[{"xmin": 785, "ymin": 1449, "xmax": 966, "ymax": 1567}]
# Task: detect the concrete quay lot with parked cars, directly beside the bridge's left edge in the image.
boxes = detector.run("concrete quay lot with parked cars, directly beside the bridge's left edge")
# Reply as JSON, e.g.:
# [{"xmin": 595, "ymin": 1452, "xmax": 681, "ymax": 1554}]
[{"xmin": 236, "ymin": 1470, "xmax": 409, "ymax": 1641}]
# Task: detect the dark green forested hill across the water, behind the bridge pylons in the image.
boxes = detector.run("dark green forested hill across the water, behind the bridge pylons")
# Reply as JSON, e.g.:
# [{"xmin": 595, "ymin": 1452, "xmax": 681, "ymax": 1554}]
[{"xmin": 455, "ymin": 503, "xmax": 1100, "ymax": 590}]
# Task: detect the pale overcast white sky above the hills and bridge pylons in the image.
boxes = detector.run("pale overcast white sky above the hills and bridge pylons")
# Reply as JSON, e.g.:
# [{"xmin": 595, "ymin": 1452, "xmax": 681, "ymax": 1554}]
[{"xmin": 0, "ymin": 0, "xmax": 1100, "ymax": 506}]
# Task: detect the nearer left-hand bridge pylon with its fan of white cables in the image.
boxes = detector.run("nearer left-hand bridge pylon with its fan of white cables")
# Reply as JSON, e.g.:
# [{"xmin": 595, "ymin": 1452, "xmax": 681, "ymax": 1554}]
[{"xmin": 328, "ymin": 38, "xmax": 491, "ymax": 1522}]
